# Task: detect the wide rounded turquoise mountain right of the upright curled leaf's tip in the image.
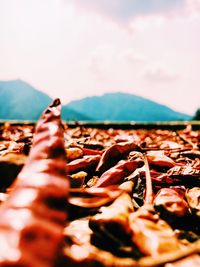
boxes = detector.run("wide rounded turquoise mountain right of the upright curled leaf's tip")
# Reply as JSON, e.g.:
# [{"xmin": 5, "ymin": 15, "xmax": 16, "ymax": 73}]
[{"xmin": 67, "ymin": 93, "xmax": 191, "ymax": 122}]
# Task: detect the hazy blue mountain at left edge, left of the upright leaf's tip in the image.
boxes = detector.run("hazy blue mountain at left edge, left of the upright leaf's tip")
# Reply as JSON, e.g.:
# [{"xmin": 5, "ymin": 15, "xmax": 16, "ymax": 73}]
[{"xmin": 0, "ymin": 80, "xmax": 52, "ymax": 120}]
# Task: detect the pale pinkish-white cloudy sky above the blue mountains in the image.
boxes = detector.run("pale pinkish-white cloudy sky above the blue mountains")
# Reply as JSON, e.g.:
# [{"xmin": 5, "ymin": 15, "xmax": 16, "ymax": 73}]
[{"xmin": 0, "ymin": 0, "xmax": 200, "ymax": 115}]
